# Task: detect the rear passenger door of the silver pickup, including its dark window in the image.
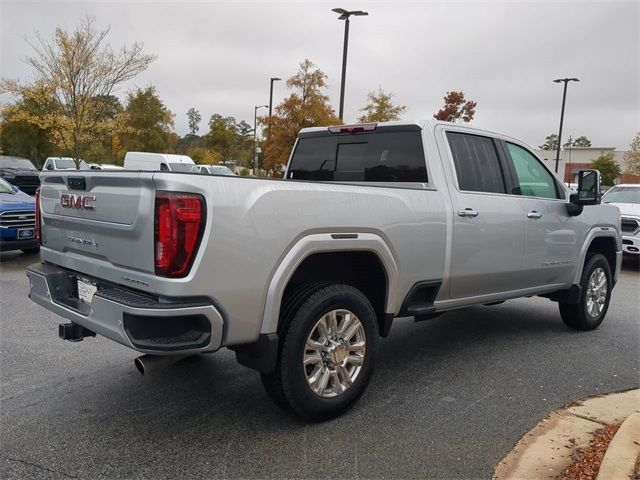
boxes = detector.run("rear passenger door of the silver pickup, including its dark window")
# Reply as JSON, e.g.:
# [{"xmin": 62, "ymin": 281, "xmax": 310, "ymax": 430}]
[{"xmin": 437, "ymin": 127, "xmax": 525, "ymax": 299}]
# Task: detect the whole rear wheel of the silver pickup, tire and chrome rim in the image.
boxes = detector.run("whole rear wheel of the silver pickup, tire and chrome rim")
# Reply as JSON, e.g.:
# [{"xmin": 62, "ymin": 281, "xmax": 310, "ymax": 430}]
[{"xmin": 262, "ymin": 284, "xmax": 378, "ymax": 421}]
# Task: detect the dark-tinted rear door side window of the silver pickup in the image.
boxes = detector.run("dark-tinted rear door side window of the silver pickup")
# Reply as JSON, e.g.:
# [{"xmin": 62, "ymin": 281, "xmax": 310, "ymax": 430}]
[{"xmin": 447, "ymin": 132, "xmax": 506, "ymax": 193}]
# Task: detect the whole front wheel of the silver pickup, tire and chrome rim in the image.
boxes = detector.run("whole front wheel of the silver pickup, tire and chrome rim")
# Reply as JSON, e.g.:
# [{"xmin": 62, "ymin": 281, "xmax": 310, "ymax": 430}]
[{"xmin": 559, "ymin": 254, "xmax": 613, "ymax": 330}]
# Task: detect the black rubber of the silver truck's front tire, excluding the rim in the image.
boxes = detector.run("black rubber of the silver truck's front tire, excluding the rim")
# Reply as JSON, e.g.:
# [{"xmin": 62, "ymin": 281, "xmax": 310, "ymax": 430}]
[{"xmin": 558, "ymin": 253, "xmax": 613, "ymax": 331}]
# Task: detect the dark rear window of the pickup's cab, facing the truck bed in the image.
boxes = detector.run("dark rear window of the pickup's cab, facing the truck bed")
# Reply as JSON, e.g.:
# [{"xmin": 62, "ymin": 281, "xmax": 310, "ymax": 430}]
[{"xmin": 287, "ymin": 126, "xmax": 428, "ymax": 183}]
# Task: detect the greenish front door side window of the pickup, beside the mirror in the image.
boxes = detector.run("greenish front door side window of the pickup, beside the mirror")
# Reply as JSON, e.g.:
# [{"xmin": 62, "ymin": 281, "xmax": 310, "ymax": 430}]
[{"xmin": 507, "ymin": 142, "xmax": 560, "ymax": 198}]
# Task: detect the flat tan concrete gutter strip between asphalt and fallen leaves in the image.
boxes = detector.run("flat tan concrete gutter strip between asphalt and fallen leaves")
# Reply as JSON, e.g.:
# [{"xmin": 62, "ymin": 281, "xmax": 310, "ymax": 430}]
[{"xmin": 493, "ymin": 389, "xmax": 640, "ymax": 480}]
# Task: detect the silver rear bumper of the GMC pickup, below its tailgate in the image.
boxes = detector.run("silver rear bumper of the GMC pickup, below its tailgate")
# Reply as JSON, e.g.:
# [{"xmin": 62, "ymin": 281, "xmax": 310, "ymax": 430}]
[{"xmin": 27, "ymin": 263, "xmax": 224, "ymax": 355}]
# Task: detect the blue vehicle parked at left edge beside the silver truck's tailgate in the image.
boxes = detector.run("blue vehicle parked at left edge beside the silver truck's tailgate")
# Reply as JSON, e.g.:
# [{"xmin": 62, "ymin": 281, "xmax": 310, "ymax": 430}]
[{"xmin": 0, "ymin": 178, "xmax": 40, "ymax": 253}]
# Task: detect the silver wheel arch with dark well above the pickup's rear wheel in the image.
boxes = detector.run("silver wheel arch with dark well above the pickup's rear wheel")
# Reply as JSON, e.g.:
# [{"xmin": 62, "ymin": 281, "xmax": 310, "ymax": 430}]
[{"xmin": 260, "ymin": 232, "xmax": 398, "ymax": 334}]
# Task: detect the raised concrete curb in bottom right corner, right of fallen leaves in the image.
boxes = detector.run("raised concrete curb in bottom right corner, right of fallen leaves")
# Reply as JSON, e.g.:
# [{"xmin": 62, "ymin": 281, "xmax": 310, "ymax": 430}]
[{"xmin": 596, "ymin": 412, "xmax": 640, "ymax": 480}]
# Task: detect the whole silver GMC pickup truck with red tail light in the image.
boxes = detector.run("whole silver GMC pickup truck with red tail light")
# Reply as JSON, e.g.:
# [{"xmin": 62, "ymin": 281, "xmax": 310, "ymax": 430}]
[{"xmin": 27, "ymin": 121, "xmax": 622, "ymax": 421}]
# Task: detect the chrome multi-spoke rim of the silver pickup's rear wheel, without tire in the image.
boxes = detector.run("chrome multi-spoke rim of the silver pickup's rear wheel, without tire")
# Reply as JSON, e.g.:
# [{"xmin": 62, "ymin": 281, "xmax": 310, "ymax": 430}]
[{"xmin": 303, "ymin": 310, "xmax": 367, "ymax": 398}]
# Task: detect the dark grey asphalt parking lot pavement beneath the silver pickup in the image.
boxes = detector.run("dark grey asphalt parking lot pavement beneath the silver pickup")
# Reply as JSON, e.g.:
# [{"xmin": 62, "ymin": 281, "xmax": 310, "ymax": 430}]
[{"xmin": 0, "ymin": 253, "xmax": 640, "ymax": 479}]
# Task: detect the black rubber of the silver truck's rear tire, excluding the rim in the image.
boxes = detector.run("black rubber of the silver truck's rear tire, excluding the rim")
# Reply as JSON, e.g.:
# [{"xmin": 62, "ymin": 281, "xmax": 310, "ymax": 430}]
[{"xmin": 261, "ymin": 283, "xmax": 378, "ymax": 422}]
